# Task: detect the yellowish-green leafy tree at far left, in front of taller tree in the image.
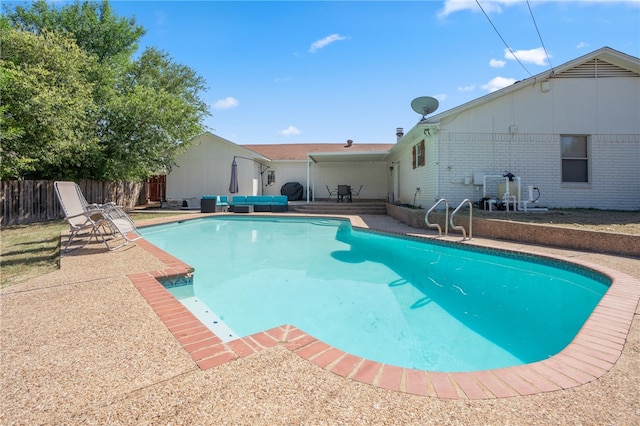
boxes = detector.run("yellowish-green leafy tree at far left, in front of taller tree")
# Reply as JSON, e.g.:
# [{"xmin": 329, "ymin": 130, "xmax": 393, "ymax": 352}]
[{"xmin": 0, "ymin": 26, "xmax": 100, "ymax": 179}]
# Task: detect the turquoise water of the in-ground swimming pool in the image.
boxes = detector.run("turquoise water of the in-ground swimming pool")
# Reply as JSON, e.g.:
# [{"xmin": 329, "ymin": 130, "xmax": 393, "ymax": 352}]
[{"xmin": 145, "ymin": 216, "xmax": 610, "ymax": 372}]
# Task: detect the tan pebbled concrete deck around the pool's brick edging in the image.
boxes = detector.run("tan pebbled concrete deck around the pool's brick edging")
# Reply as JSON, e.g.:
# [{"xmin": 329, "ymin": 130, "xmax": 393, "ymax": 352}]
[{"xmin": 0, "ymin": 215, "xmax": 640, "ymax": 424}]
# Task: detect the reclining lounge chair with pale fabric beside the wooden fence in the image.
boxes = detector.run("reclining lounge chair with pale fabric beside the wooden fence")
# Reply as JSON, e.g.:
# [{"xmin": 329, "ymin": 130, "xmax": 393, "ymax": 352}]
[{"xmin": 54, "ymin": 181, "xmax": 142, "ymax": 252}]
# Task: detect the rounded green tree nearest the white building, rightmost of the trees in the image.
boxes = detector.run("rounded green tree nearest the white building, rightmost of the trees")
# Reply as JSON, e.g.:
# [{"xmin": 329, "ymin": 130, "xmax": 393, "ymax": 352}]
[{"xmin": 100, "ymin": 49, "xmax": 208, "ymax": 179}]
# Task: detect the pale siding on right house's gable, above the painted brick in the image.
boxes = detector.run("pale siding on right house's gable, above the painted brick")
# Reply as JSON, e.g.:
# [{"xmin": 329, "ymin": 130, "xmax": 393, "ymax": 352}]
[{"xmin": 440, "ymin": 76, "xmax": 640, "ymax": 134}]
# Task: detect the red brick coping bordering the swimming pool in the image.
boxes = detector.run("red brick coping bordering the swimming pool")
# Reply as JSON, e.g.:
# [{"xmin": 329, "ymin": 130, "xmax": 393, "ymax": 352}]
[{"xmin": 129, "ymin": 230, "xmax": 640, "ymax": 400}]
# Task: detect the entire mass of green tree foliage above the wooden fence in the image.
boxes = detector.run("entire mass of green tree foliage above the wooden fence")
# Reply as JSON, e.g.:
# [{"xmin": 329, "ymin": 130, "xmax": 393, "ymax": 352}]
[{"xmin": 0, "ymin": 0, "xmax": 209, "ymax": 180}]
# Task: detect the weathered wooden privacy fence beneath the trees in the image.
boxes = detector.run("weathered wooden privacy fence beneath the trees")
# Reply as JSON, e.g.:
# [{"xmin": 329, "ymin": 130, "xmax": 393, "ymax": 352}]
[{"xmin": 0, "ymin": 180, "xmax": 146, "ymax": 226}]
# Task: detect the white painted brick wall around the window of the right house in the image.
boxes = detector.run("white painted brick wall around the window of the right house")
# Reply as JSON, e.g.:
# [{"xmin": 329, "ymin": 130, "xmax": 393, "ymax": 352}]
[{"xmin": 439, "ymin": 133, "xmax": 640, "ymax": 210}]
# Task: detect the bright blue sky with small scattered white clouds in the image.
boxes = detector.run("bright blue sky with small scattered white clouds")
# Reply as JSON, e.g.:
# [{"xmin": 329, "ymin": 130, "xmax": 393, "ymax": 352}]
[{"xmin": 90, "ymin": 0, "xmax": 640, "ymax": 144}]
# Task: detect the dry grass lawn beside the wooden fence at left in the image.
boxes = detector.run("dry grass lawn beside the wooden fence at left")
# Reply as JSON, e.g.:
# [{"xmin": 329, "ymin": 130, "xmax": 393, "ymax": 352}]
[{"xmin": 0, "ymin": 213, "xmax": 189, "ymax": 288}]
